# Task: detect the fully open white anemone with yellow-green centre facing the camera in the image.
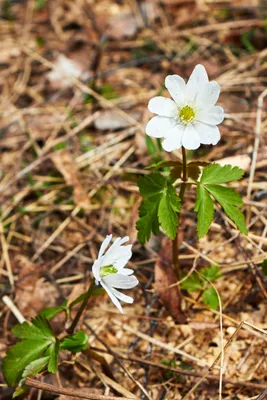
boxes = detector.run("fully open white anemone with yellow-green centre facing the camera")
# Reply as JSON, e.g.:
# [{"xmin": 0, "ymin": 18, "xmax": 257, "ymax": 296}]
[{"xmin": 146, "ymin": 64, "xmax": 224, "ymax": 151}]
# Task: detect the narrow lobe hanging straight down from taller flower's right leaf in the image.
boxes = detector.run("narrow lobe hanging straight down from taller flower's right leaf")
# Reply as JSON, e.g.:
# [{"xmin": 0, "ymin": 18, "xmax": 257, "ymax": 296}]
[{"xmin": 195, "ymin": 183, "xmax": 214, "ymax": 238}]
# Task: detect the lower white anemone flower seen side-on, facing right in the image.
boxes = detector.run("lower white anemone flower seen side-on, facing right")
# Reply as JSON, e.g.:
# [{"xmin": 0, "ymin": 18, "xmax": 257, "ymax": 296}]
[{"xmin": 92, "ymin": 235, "xmax": 139, "ymax": 313}]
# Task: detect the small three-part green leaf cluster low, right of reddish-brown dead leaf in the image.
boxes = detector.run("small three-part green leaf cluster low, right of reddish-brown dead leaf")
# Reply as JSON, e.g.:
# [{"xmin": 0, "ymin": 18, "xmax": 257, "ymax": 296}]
[{"xmin": 181, "ymin": 265, "xmax": 222, "ymax": 310}]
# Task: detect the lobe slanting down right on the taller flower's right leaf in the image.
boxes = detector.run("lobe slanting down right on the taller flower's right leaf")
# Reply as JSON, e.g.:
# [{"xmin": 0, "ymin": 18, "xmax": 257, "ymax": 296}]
[{"xmin": 206, "ymin": 185, "xmax": 248, "ymax": 235}]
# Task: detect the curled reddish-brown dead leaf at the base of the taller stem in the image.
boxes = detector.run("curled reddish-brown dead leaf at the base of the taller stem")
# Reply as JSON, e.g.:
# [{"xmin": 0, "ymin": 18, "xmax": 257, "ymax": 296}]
[{"xmin": 155, "ymin": 239, "xmax": 186, "ymax": 324}]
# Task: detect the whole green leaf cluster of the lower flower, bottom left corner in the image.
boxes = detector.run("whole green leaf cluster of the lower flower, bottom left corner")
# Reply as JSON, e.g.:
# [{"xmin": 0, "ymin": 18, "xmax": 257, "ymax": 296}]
[{"xmin": 3, "ymin": 301, "xmax": 89, "ymax": 397}]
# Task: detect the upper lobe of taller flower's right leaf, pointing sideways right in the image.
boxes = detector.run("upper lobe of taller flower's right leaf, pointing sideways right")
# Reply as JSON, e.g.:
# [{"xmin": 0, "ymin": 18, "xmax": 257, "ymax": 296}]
[{"xmin": 200, "ymin": 164, "xmax": 244, "ymax": 185}]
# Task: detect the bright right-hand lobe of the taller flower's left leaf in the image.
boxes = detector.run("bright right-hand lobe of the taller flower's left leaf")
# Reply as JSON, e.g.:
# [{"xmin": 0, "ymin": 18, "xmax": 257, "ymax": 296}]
[{"xmin": 158, "ymin": 185, "xmax": 181, "ymax": 239}]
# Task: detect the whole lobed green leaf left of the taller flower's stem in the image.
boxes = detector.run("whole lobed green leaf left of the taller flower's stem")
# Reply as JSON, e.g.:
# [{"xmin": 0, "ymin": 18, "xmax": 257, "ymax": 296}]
[{"xmin": 136, "ymin": 172, "xmax": 181, "ymax": 244}]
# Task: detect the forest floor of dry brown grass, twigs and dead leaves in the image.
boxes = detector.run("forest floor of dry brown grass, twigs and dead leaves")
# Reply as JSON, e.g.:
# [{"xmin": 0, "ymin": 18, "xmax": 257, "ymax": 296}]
[{"xmin": 0, "ymin": 0, "xmax": 267, "ymax": 400}]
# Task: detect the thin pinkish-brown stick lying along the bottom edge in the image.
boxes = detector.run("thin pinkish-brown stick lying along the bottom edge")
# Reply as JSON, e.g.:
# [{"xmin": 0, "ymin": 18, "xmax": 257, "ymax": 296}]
[{"xmin": 25, "ymin": 378, "xmax": 132, "ymax": 400}]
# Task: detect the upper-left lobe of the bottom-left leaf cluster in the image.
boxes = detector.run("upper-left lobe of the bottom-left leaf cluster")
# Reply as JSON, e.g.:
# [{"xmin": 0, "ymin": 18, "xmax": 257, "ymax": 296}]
[{"xmin": 12, "ymin": 315, "xmax": 54, "ymax": 340}]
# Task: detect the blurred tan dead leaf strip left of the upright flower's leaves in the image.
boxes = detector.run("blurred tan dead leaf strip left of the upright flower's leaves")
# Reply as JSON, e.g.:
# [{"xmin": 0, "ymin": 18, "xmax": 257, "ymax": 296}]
[{"xmin": 51, "ymin": 149, "xmax": 89, "ymax": 210}]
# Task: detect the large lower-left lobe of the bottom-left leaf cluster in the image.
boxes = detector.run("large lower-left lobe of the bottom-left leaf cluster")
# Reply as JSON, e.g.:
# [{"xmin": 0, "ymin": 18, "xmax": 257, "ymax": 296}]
[{"xmin": 3, "ymin": 339, "xmax": 51, "ymax": 386}]
